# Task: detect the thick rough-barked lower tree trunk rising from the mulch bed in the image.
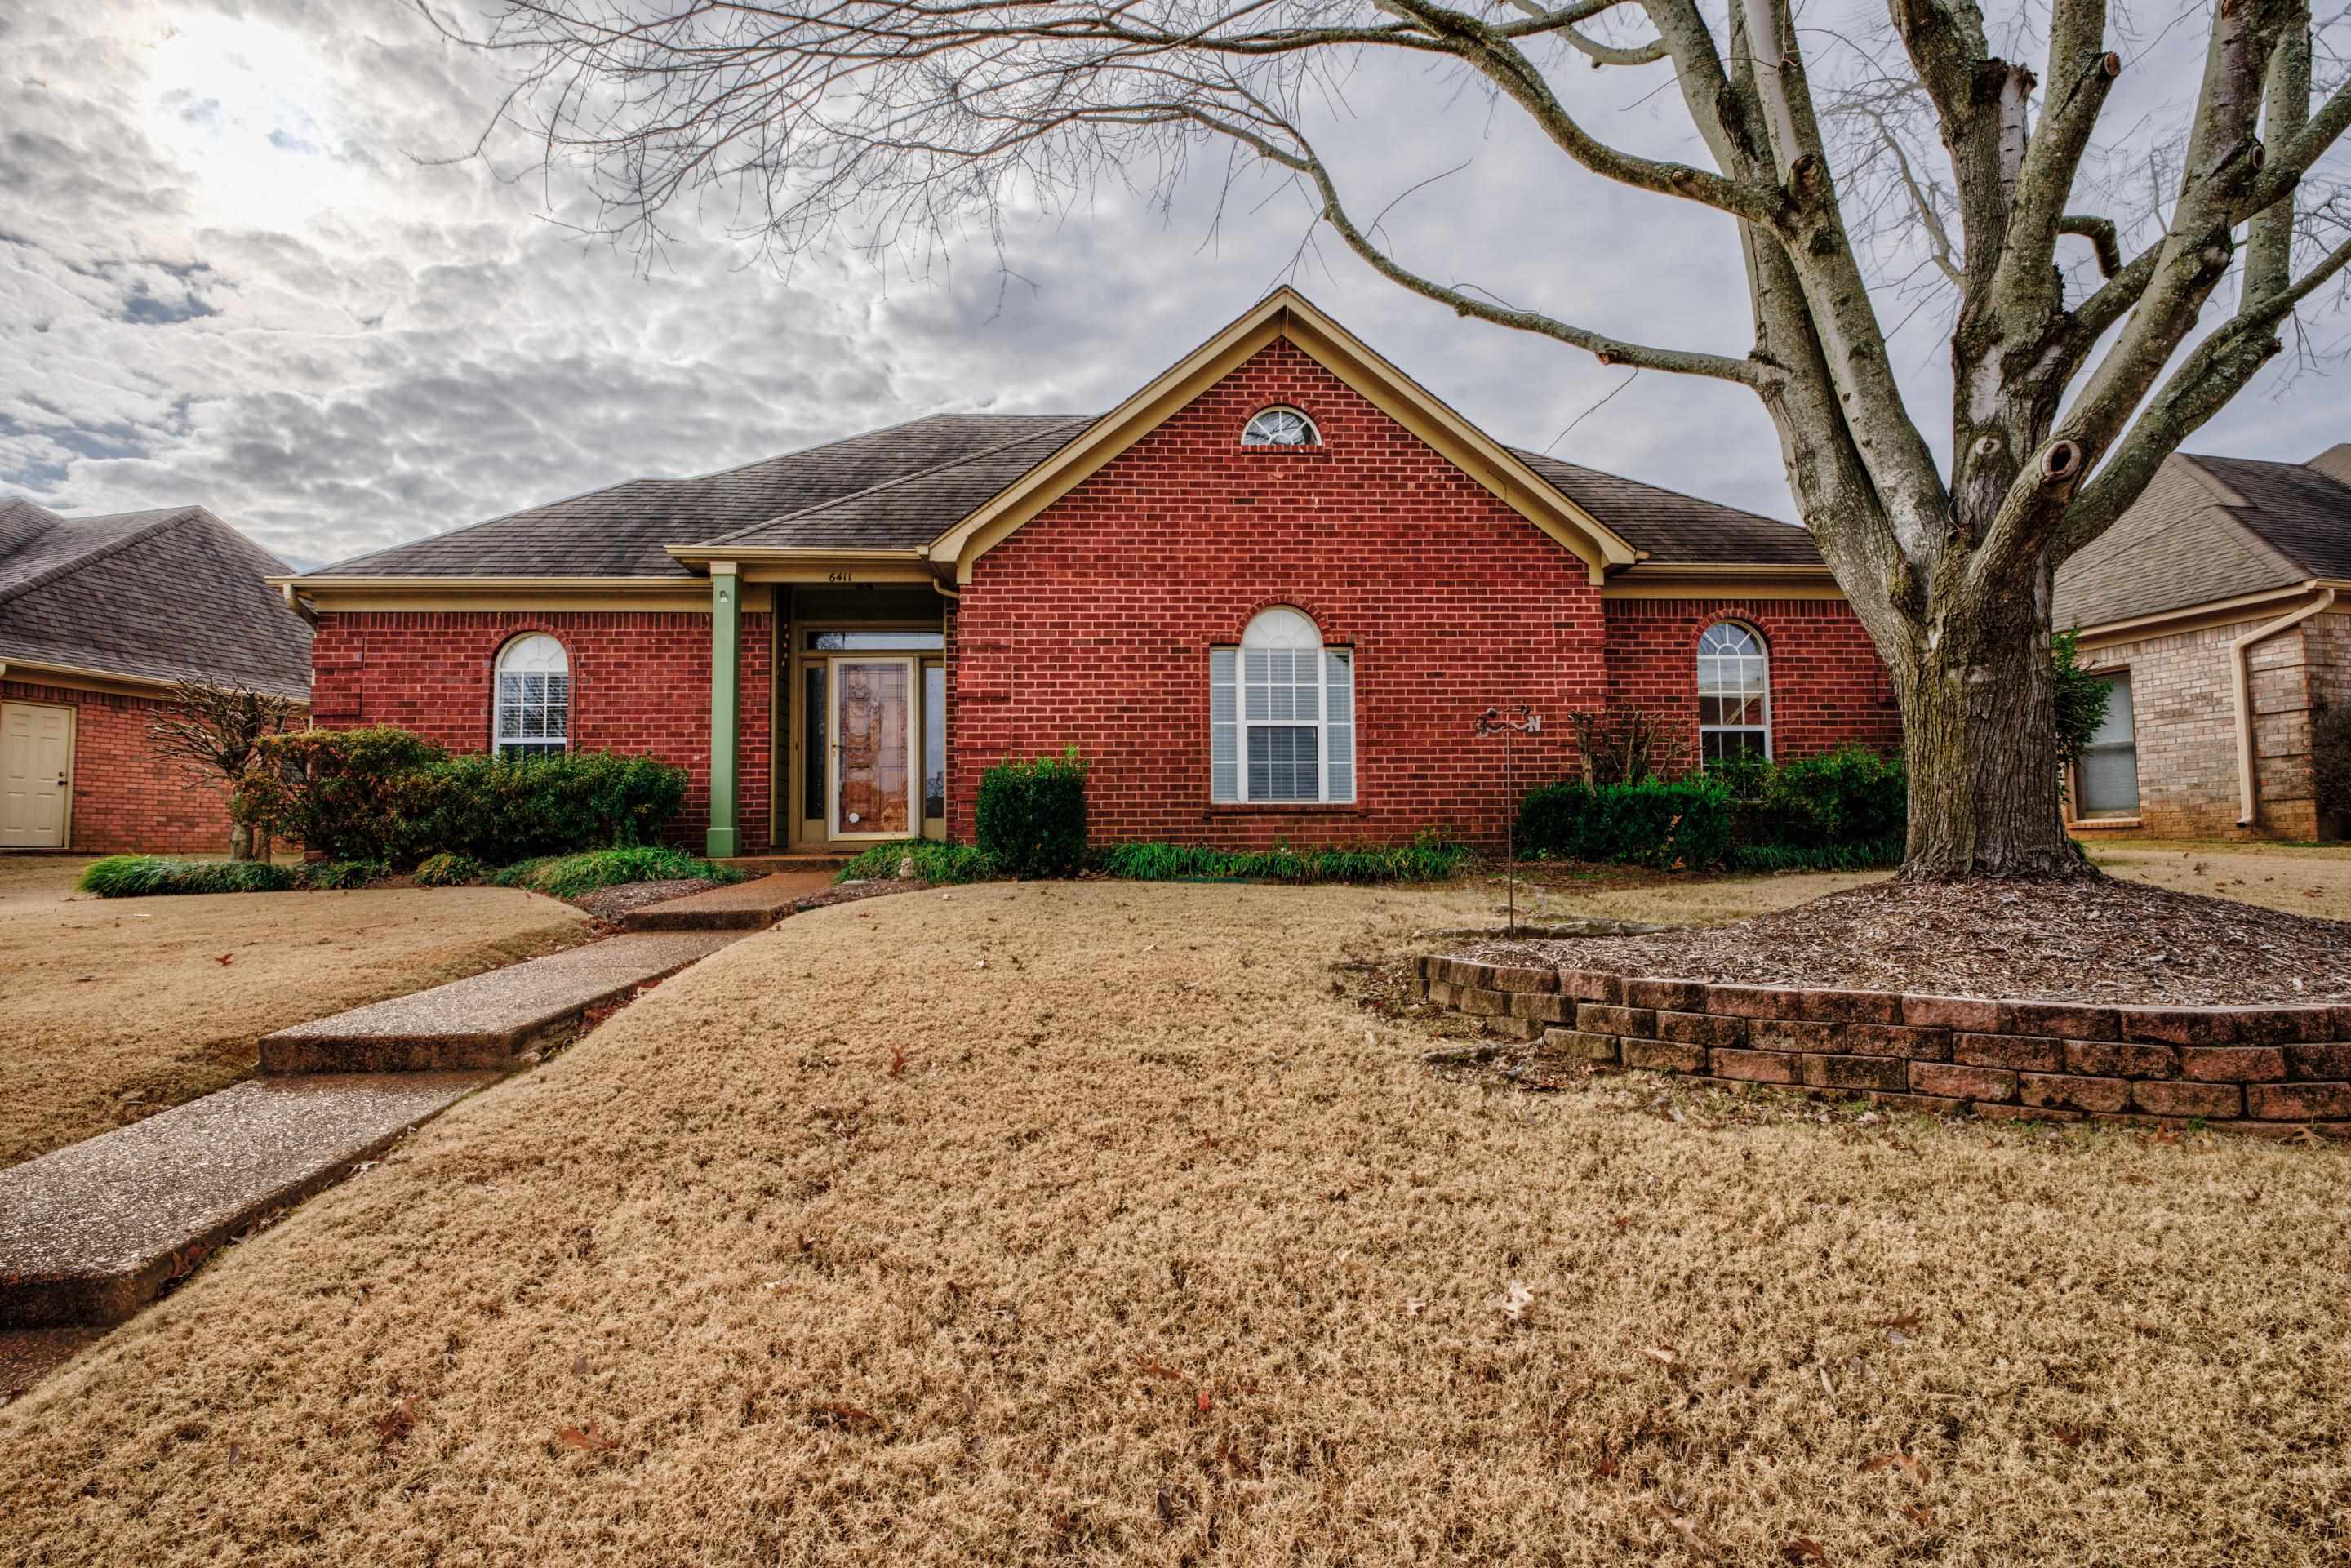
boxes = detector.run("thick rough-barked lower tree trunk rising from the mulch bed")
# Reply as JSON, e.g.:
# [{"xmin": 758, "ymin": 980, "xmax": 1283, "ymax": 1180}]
[{"xmin": 1891, "ymin": 576, "xmax": 2086, "ymax": 882}]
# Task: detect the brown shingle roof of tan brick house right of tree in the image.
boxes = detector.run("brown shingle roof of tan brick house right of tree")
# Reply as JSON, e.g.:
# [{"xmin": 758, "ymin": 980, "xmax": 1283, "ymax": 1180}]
[{"xmin": 2055, "ymin": 446, "xmax": 2351, "ymax": 628}]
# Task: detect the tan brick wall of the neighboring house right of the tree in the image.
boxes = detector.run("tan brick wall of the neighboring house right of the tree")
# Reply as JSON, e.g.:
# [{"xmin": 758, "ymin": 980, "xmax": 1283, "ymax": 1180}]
[{"xmin": 2083, "ymin": 616, "xmax": 2335, "ymax": 839}]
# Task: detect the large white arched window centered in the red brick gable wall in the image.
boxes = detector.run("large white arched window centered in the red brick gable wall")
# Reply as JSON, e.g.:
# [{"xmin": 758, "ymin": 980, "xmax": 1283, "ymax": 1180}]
[{"xmin": 1208, "ymin": 604, "xmax": 1354, "ymax": 802}]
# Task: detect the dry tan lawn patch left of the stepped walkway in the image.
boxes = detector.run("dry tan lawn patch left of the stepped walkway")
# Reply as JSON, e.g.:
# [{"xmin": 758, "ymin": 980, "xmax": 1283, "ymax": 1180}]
[{"xmin": 0, "ymin": 855, "xmax": 588, "ymax": 1166}]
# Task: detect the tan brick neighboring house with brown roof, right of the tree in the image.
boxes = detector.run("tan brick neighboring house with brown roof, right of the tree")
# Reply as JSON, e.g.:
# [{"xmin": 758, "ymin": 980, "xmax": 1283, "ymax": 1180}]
[{"xmin": 2057, "ymin": 444, "xmax": 2351, "ymax": 839}]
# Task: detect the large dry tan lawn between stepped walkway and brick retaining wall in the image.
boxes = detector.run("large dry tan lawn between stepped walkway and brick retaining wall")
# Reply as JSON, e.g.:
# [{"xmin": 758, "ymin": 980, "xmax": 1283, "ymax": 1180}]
[{"xmin": 0, "ymin": 884, "xmax": 2351, "ymax": 1566}]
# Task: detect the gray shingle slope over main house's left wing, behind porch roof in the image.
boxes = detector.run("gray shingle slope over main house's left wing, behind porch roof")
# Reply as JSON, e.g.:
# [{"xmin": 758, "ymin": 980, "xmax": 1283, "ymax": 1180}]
[{"xmin": 318, "ymin": 414, "xmax": 1091, "ymax": 578}]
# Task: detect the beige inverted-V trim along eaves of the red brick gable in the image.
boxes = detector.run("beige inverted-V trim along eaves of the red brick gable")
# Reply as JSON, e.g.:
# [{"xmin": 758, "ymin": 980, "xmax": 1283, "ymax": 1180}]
[{"xmin": 929, "ymin": 284, "xmax": 1641, "ymax": 585}]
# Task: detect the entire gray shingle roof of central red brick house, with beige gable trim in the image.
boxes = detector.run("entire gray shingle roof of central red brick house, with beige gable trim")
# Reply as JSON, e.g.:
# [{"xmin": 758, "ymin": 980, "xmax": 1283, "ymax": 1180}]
[{"xmin": 294, "ymin": 289, "xmax": 1820, "ymax": 588}]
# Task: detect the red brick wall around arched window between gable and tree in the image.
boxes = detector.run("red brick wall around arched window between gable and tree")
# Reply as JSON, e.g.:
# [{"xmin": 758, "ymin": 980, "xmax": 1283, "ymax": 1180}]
[{"xmin": 1608, "ymin": 599, "xmax": 1902, "ymax": 762}]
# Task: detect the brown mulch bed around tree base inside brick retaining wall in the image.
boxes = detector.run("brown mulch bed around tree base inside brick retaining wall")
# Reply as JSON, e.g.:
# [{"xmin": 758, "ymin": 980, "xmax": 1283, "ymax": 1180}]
[{"xmin": 1455, "ymin": 877, "xmax": 2351, "ymax": 1006}]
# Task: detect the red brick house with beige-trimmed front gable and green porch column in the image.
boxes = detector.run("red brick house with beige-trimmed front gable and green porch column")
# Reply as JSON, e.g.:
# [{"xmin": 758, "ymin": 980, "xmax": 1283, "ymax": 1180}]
[{"xmin": 284, "ymin": 289, "xmax": 1900, "ymax": 855}]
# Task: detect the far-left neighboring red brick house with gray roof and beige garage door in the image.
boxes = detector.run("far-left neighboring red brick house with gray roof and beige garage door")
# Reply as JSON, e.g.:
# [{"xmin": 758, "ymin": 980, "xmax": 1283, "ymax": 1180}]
[{"xmin": 0, "ymin": 500, "xmax": 310, "ymax": 853}]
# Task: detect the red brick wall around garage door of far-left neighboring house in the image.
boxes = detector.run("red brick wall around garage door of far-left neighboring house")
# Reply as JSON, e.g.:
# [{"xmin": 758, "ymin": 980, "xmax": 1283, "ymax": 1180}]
[{"xmin": 0, "ymin": 682, "xmax": 257, "ymax": 855}]
